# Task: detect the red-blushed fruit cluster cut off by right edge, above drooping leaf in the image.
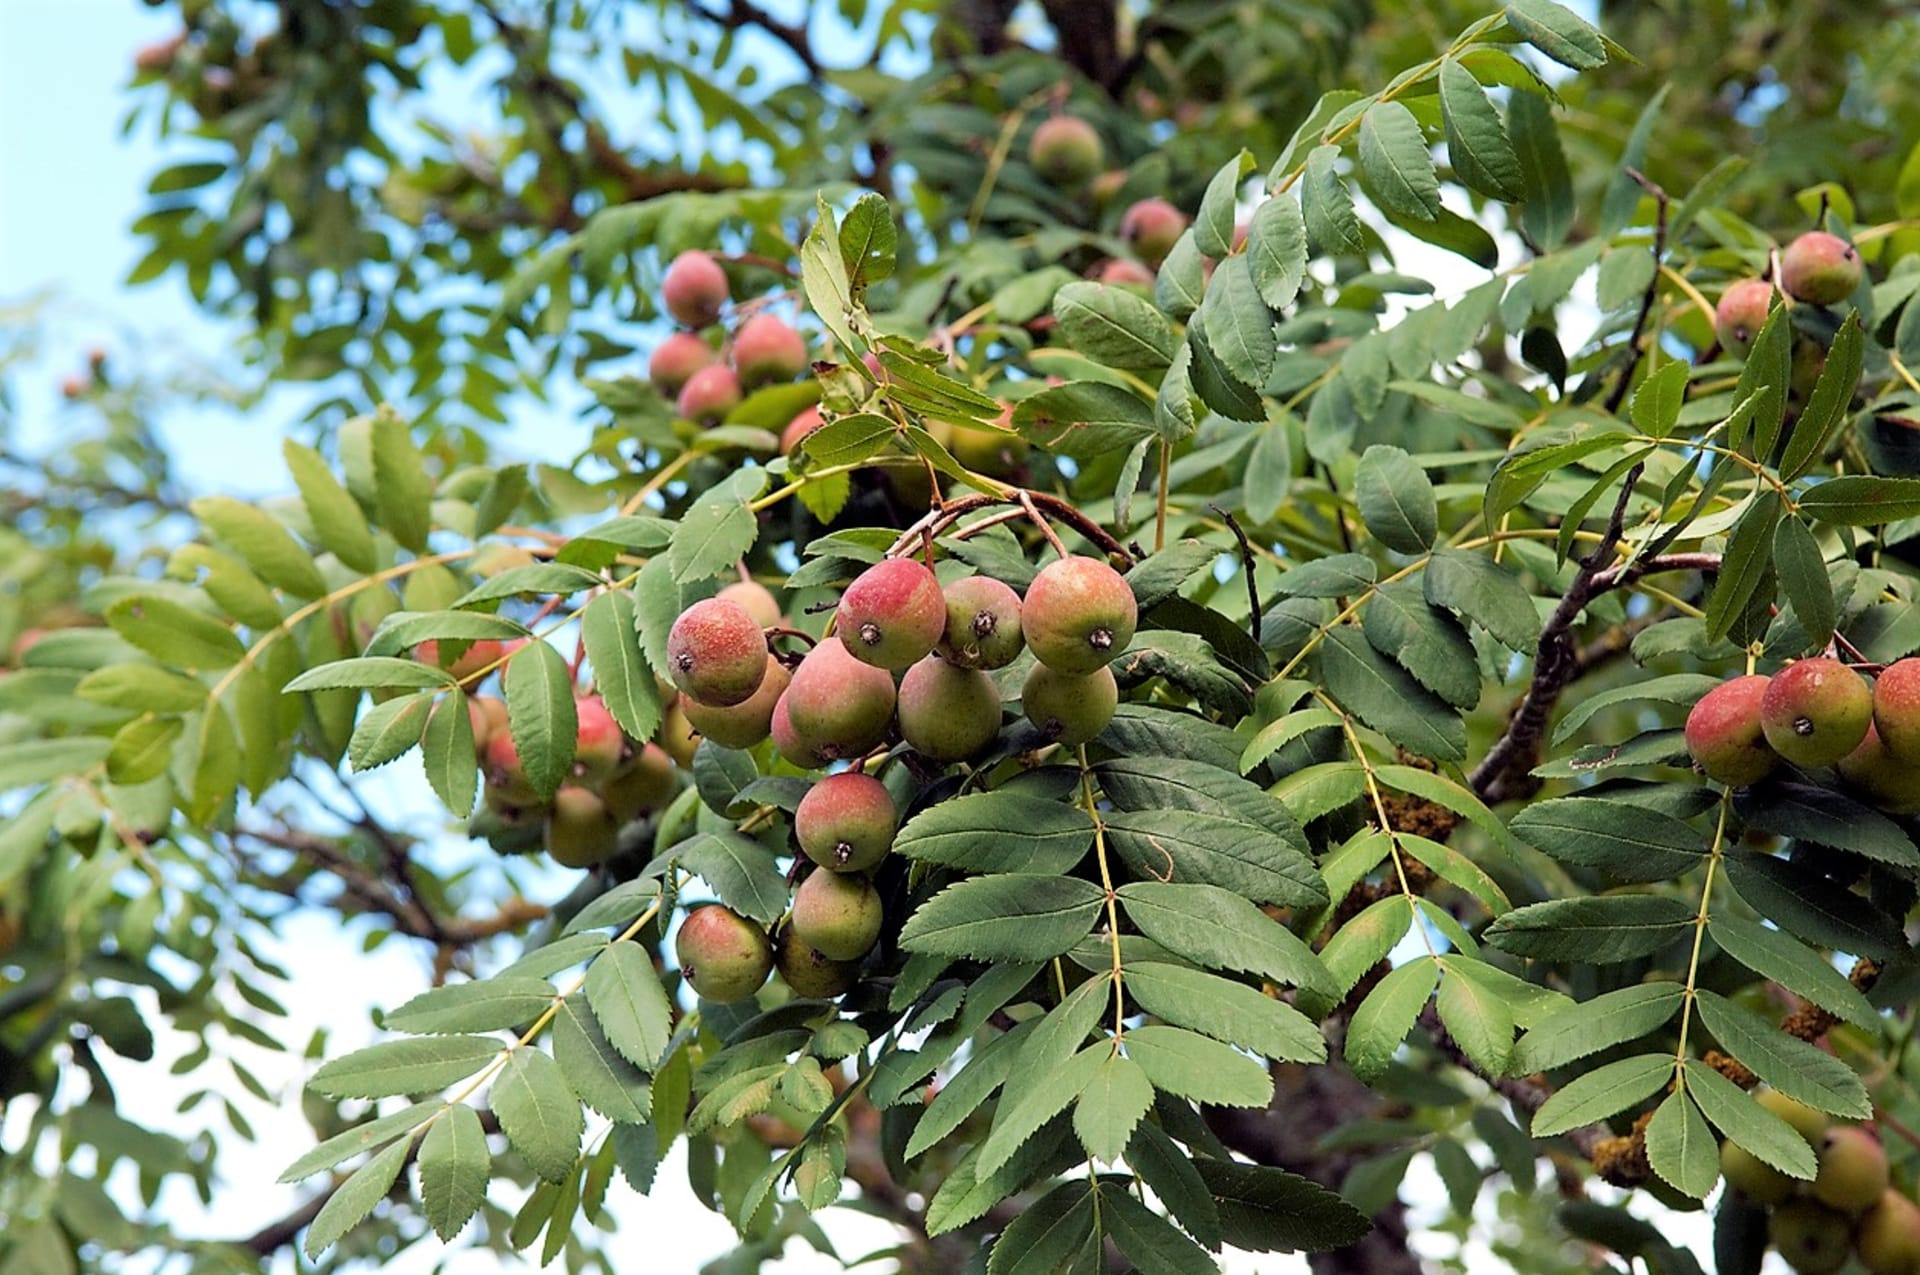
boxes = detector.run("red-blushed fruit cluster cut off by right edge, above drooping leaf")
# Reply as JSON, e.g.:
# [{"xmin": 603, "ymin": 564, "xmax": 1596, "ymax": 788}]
[{"xmin": 1686, "ymin": 657, "xmax": 1920, "ymax": 814}]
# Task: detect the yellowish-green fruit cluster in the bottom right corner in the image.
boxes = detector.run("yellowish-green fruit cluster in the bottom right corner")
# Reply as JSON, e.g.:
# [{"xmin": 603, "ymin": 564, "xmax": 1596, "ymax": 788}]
[{"xmin": 1720, "ymin": 1089, "xmax": 1920, "ymax": 1275}]
